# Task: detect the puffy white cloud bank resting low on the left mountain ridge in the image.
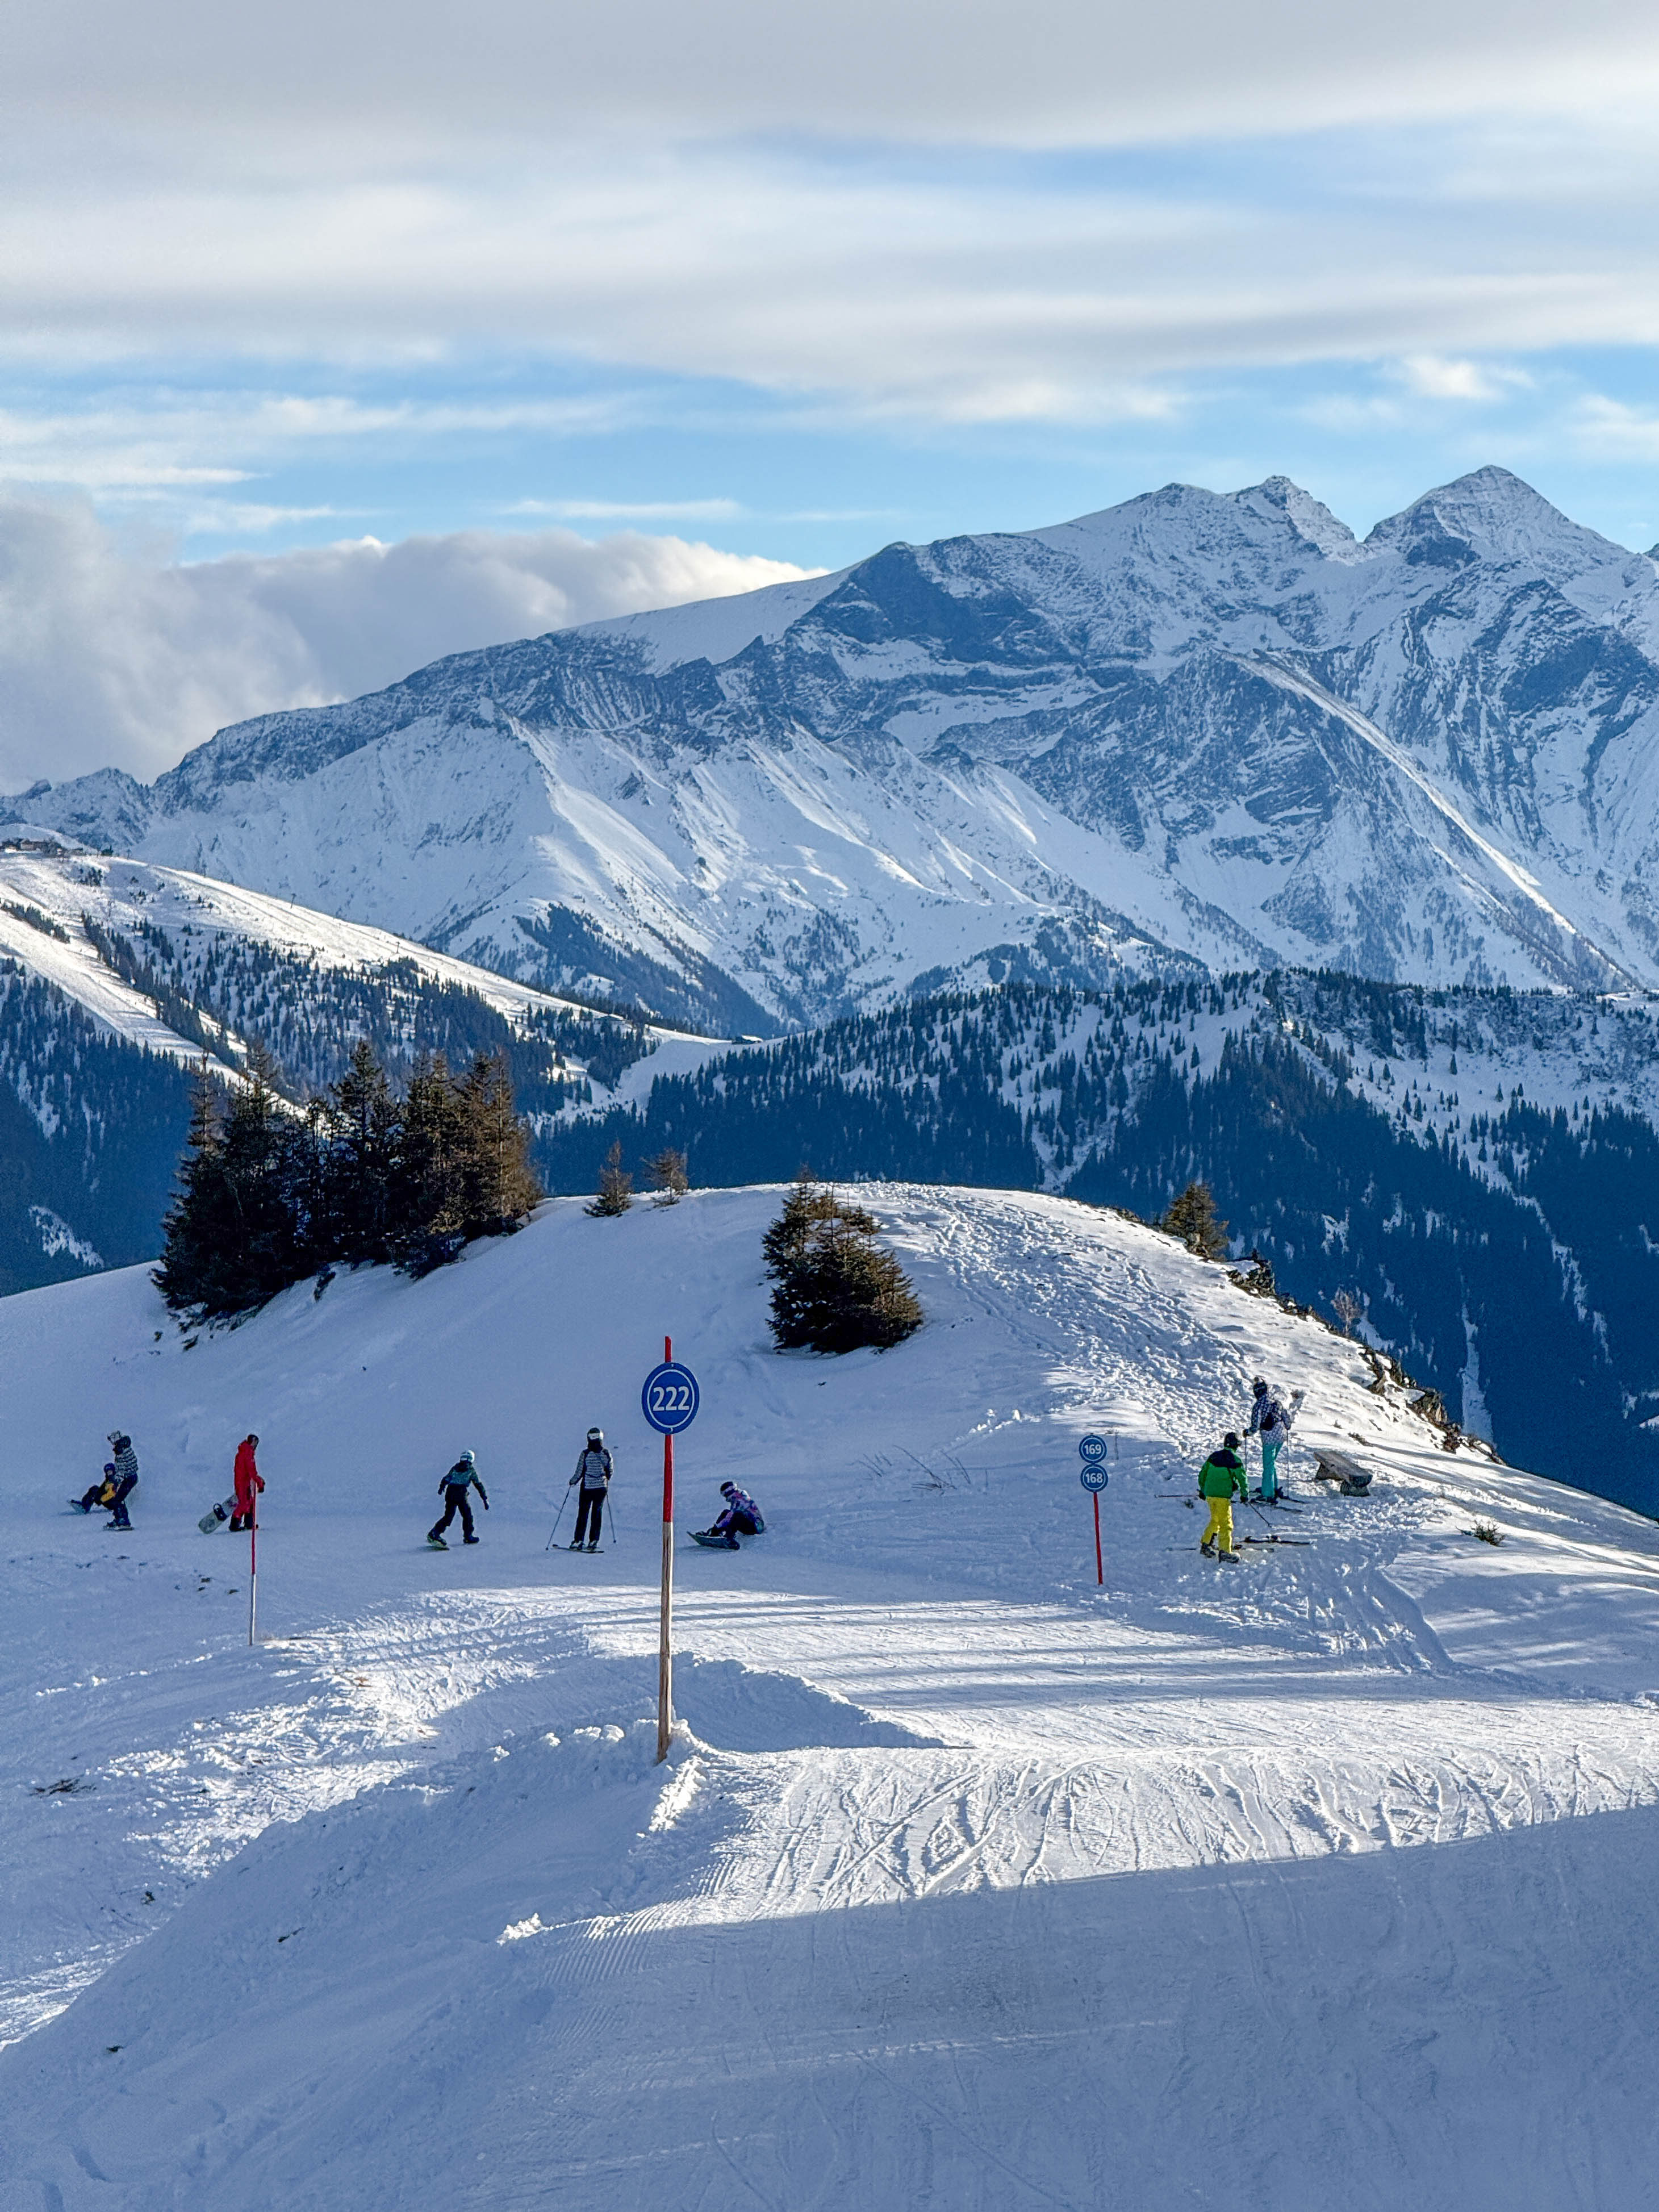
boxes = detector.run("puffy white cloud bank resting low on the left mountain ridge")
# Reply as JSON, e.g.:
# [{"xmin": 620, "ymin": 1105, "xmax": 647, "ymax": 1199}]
[{"xmin": 0, "ymin": 498, "xmax": 827, "ymax": 790}]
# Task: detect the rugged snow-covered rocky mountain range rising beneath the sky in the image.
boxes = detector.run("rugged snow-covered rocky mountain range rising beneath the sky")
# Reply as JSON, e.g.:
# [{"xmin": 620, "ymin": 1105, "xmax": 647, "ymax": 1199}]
[{"xmin": 19, "ymin": 469, "xmax": 1659, "ymax": 1035}]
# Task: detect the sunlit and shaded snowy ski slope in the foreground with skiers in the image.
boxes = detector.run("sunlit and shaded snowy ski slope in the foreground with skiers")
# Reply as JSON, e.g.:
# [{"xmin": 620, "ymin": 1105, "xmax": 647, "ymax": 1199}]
[{"xmin": 0, "ymin": 1188, "xmax": 1659, "ymax": 2212}]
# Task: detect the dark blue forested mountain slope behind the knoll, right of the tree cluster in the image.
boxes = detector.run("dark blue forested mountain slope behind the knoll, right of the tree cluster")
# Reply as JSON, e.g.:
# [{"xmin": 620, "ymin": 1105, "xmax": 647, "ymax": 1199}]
[{"xmin": 553, "ymin": 973, "xmax": 1659, "ymax": 1511}]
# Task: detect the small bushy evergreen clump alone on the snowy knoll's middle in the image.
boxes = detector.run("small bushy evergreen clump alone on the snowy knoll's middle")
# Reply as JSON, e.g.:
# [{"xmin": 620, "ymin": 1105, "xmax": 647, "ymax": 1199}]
[{"xmin": 761, "ymin": 1168, "xmax": 922, "ymax": 1351}]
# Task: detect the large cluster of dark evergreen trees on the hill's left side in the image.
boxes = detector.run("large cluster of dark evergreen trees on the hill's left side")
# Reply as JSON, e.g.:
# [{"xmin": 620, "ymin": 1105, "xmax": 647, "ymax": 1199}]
[{"xmin": 155, "ymin": 1040, "xmax": 542, "ymax": 1318}]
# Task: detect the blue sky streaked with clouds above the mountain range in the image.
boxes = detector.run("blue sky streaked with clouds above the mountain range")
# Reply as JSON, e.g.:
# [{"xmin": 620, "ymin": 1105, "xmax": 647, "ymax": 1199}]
[{"xmin": 0, "ymin": 0, "xmax": 1659, "ymax": 777}]
